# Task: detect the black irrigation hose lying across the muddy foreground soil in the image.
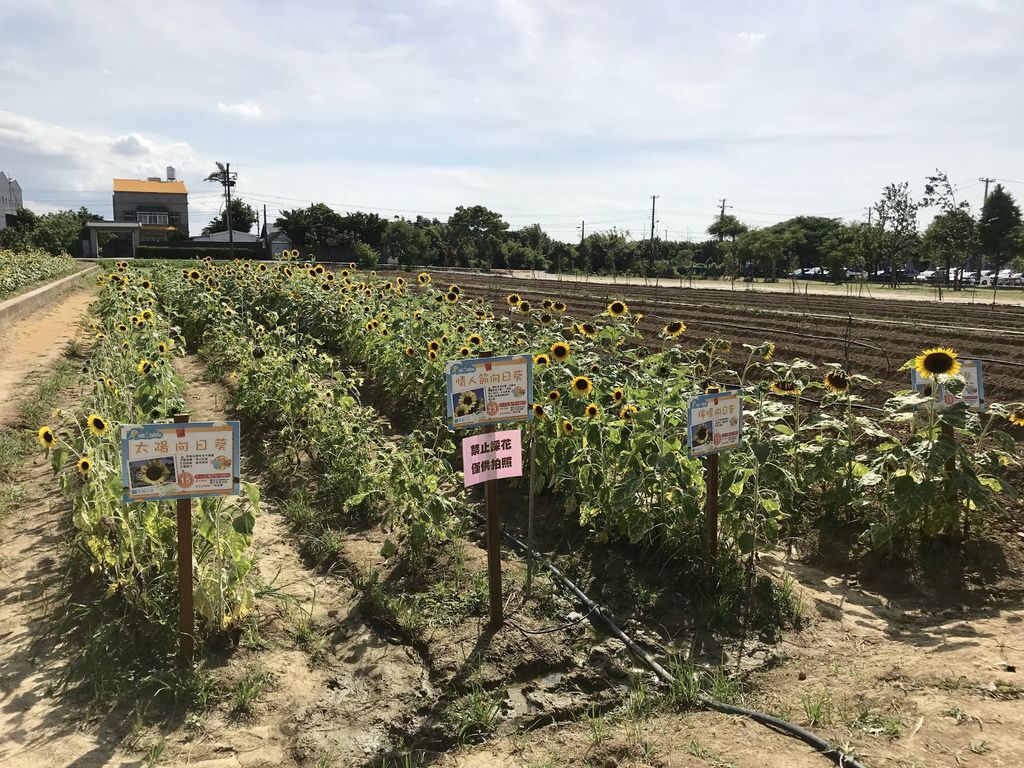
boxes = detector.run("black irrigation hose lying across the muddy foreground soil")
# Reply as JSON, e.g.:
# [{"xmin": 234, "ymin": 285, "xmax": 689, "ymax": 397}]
[{"xmin": 491, "ymin": 531, "xmax": 865, "ymax": 768}]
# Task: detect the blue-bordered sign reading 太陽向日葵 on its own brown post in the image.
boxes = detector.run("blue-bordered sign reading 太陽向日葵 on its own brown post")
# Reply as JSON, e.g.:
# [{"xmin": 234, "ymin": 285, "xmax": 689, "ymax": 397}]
[{"xmin": 121, "ymin": 421, "xmax": 241, "ymax": 502}]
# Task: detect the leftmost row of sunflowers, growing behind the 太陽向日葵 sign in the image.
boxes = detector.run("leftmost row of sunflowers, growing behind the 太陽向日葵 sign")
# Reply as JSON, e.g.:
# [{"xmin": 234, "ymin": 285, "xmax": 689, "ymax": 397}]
[{"xmin": 38, "ymin": 263, "xmax": 258, "ymax": 666}]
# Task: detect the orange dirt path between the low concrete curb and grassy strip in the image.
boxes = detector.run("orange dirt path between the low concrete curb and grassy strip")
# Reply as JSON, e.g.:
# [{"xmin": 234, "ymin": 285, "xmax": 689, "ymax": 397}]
[{"xmin": 0, "ymin": 289, "xmax": 95, "ymax": 424}]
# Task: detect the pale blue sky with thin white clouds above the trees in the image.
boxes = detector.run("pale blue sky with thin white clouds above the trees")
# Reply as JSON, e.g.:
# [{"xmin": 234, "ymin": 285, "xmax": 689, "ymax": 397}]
[{"xmin": 0, "ymin": 0, "xmax": 1024, "ymax": 240}]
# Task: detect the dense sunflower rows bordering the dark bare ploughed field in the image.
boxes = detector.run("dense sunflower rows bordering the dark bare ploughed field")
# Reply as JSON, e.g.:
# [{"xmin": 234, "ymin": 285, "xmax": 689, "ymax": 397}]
[{"xmin": 144, "ymin": 256, "xmax": 1024, "ymax": 557}]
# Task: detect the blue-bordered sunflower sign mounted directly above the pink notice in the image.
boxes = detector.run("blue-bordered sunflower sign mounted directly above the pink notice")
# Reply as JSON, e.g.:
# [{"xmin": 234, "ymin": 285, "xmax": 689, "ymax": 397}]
[{"xmin": 444, "ymin": 354, "xmax": 534, "ymax": 429}]
